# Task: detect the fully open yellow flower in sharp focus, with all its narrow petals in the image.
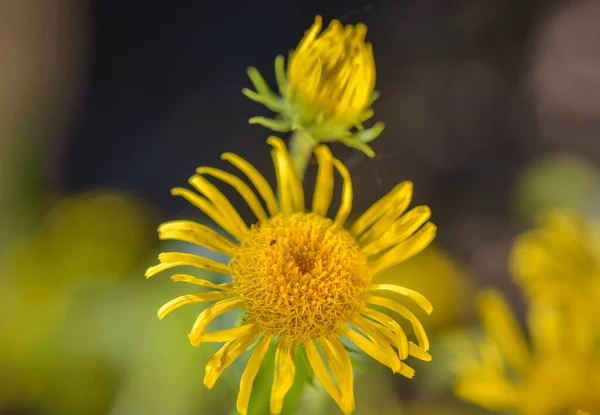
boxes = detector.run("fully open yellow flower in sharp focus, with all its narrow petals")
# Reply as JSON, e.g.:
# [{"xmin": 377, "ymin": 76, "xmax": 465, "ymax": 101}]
[{"xmin": 146, "ymin": 137, "xmax": 436, "ymax": 414}]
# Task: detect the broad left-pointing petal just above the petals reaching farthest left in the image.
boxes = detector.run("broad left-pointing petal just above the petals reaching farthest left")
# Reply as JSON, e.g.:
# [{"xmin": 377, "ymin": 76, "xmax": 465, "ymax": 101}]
[{"xmin": 158, "ymin": 220, "xmax": 237, "ymax": 256}]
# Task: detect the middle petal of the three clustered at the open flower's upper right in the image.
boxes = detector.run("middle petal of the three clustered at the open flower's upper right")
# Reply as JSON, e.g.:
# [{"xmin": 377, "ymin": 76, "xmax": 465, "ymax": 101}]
[{"xmin": 361, "ymin": 206, "xmax": 431, "ymax": 256}]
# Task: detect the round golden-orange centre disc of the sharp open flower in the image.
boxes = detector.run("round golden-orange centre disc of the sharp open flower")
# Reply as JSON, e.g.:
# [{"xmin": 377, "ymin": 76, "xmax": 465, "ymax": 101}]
[{"xmin": 230, "ymin": 213, "xmax": 371, "ymax": 342}]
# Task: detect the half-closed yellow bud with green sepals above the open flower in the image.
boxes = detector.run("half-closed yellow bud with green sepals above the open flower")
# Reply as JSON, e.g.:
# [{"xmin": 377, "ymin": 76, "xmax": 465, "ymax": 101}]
[{"xmin": 243, "ymin": 16, "xmax": 384, "ymax": 156}]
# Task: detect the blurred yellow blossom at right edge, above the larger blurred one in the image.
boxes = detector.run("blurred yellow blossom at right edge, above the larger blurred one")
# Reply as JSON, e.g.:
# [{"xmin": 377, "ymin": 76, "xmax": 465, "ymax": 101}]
[{"xmin": 510, "ymin": 210, "xmax": 600, "ymax": 324}]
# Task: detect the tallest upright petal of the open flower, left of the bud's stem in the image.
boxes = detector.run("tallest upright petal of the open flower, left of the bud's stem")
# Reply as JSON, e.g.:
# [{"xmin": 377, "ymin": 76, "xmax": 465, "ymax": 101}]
[{"xmin": 267, "ymin": 136, "xmax": 304, "ymax": 213}]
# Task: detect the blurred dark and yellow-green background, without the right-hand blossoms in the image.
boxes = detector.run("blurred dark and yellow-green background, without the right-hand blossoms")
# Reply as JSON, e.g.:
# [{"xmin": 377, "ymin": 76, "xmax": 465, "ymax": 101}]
[{"xmin": 0, "ymin": 0, "xmax": 600, "ymax": 415}]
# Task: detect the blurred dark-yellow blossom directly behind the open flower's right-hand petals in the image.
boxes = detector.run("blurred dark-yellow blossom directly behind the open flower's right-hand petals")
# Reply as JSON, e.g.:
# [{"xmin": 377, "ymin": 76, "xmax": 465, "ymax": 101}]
[{"xmin": 374, "ymin": 245, "xmax": 473, "ymax": 330}]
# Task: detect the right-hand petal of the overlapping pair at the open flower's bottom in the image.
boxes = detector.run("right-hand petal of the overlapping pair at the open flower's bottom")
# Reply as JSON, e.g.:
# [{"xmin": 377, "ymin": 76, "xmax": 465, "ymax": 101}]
[{"xmin": 321, "ymin": 335, "xmax": 355, "ymax": 410}]
